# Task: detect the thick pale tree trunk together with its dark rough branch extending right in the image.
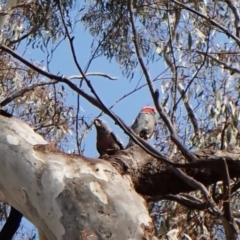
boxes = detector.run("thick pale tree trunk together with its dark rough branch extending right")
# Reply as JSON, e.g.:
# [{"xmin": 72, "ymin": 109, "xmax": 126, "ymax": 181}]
[{"xmin": 0, "ymin": 116, "xmax": 240, "ymax": 240}]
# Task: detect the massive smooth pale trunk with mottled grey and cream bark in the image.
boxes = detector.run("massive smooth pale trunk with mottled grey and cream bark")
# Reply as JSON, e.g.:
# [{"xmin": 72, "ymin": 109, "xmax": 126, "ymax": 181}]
[{"xmin": 0, "ymin": 116, "xmax": 153, "ymax": 240}]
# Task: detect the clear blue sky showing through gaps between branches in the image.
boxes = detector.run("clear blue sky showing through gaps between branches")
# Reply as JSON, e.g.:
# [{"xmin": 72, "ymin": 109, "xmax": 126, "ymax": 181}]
[{"xmin": 13, "ymin": 5, "xmax": 165, "ymax": 239}]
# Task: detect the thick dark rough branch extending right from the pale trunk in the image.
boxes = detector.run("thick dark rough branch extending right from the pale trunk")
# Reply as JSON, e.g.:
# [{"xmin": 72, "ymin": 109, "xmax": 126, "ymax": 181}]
[{"xmin": 110, "ymin": 145, "xmax": 240, "ymax": 198}]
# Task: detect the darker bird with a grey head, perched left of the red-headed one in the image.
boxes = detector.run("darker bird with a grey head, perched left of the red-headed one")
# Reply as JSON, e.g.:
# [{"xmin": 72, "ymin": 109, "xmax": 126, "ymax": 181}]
[{"xmin": 94, "ymin": 118, "xmax": 123, "ymax": 156}]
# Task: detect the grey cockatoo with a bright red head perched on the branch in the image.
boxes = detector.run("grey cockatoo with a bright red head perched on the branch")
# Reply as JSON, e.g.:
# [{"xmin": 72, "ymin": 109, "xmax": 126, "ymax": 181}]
[{"xmin": 127, "ymin": 106, "xmax": 156, "ymax": 147}]
